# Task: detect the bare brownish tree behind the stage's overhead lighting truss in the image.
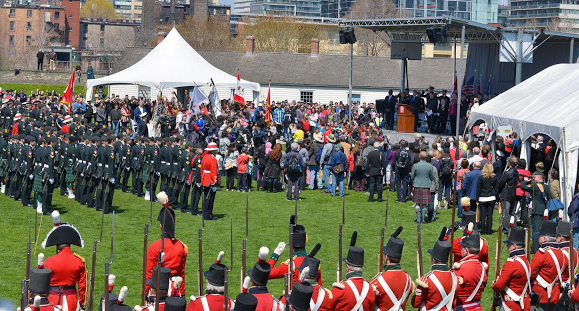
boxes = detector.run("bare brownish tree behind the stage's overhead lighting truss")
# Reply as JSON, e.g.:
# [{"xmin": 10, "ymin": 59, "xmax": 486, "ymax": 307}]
[{"xmin": 348, "ymin": 0, "xmax": 405, "ymax": 56}]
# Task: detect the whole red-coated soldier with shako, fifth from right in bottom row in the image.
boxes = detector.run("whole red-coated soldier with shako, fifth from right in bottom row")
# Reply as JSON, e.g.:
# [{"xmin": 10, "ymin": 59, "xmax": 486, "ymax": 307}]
[{"xmin": 412, "ymin": 228, "xmax": 464, "ymax": 311}]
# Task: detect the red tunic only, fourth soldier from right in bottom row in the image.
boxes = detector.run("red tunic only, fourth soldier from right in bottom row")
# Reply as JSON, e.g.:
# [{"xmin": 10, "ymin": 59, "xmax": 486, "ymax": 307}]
[{"xmin": 454, "ymin": 255, "xmax": 489, "ymax": 311}]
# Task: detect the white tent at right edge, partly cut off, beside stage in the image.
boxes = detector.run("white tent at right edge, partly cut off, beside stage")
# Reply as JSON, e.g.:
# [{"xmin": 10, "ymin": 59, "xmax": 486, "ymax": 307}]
[{"xmin": 470, "ymin": 64, "xmax": 579, "ymax": 207}]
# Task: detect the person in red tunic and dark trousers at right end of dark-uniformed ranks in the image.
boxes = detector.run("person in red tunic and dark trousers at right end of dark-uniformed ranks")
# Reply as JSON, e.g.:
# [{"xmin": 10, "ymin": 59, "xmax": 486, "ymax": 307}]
[{"xmin": 201, "ymin": 143, "xmax": 219, "ymax": 220}]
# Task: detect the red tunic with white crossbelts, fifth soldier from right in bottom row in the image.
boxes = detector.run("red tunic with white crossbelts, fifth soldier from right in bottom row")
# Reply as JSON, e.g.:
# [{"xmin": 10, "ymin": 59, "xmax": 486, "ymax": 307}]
[{"xmin": 412, "ymin": 265, "xmax": 458, "ymax": 311}]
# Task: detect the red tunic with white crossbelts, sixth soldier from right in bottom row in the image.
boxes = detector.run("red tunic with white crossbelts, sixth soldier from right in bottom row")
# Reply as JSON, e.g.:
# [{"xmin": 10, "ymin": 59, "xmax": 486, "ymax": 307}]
[{"xmin": 370, "ymin": 264, "xmax": 414, "ymax": 311}]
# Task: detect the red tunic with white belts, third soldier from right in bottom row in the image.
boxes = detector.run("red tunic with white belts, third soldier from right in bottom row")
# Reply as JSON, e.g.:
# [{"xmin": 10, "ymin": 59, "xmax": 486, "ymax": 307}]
[{"xmin": 491, "ymin": 249, "xmax": 531, "ymax": 311}]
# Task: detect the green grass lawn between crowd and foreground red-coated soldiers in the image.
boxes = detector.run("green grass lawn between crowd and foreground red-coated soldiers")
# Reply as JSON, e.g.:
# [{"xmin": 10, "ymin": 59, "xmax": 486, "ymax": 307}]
[{"xmin": 0, "ymin": 180, "xmax": 507, "ymax": 310}]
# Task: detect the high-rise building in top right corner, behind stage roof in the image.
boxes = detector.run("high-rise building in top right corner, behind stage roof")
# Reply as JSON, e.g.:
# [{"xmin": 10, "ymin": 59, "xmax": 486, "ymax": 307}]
[{"xmin": 506, "ymin": 0, "xmax": 579, "ymax": 32}]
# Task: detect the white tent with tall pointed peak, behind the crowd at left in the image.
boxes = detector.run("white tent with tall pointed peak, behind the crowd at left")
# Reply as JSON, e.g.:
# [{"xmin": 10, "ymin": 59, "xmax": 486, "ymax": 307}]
[{"xmin": 86, "ymin": 28, "xmax": 260, "ymax": 100}]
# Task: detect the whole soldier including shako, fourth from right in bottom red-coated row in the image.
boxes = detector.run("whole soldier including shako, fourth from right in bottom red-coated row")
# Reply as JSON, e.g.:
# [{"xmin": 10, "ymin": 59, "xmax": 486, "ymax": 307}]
[{"xmin": 453, "ymin": 223, "xmax": 489, "ymax": 311}]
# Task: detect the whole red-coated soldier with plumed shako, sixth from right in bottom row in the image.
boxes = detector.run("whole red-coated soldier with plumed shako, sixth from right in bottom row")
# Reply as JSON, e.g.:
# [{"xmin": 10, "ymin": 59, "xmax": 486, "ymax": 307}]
[{"xmin": 370, "ymin": 227, "xmax": 414, "ymax": 310}]
